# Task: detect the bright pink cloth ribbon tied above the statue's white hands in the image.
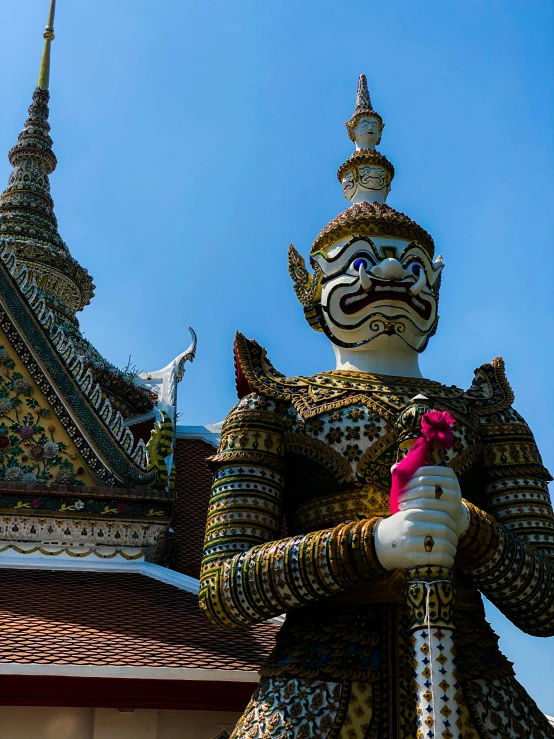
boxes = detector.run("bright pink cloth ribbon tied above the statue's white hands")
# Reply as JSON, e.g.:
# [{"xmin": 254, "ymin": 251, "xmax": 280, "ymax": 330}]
[{"xmin": 390, "ymin": 411, "xmax": 456, "ymax": 513}]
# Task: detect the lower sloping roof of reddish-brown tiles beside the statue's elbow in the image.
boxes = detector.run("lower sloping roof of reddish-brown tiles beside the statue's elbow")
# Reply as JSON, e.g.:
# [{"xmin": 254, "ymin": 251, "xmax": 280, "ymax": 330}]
[{"xmin": 0, "ymin": 569, "xmax": 278, "ymax": 671}]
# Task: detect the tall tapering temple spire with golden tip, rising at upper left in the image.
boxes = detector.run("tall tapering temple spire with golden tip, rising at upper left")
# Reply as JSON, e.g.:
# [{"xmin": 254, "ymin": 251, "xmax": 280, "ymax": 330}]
[{"xmin": 0, "ymin": 0, "xmax": 94, "ymax": 322}]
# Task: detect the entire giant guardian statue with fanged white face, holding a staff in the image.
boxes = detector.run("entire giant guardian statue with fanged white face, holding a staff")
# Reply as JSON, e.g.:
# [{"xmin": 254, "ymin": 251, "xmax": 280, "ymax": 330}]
[{"xmin": 200, "ymin": 75, "xmax": 554, "ymax": 739}]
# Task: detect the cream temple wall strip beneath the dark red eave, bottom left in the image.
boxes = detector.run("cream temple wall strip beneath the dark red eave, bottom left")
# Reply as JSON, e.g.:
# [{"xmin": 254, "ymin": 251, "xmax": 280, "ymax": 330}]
[{"xmin": 0, "ymin": 706, "xmax": 240, "ymax": 739}]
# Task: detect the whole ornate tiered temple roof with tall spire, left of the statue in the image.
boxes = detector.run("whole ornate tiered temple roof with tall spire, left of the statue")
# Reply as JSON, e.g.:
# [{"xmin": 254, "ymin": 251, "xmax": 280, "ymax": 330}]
[{"xmin": 0, "ymin": 0, "xmax": 278, "ymax": 710}]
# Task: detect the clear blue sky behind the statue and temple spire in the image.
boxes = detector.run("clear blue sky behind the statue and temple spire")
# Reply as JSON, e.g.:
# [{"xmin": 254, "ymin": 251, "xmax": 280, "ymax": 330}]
[{"xmin": 0, "ymin": 0, "xmax": 554, "ymax": 714}]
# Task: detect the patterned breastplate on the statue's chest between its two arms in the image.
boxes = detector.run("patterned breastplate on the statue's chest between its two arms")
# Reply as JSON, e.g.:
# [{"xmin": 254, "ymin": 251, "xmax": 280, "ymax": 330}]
[{"xmin": 285, "ymin": 372, "xmax": 482, "ymax": 534}]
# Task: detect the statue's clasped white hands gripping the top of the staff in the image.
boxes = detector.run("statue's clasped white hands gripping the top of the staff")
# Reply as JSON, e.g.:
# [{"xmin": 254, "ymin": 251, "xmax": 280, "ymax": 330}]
[{"xmin": 375, "ymin": 467, "xmax": 469, "ymax": 570}]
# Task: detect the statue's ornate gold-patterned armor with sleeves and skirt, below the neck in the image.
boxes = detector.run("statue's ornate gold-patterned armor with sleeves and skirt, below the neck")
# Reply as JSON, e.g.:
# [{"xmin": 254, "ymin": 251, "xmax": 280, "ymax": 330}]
[{"xmin": 200, "ymin": 335, "xmax": 554, "ymax": 739}]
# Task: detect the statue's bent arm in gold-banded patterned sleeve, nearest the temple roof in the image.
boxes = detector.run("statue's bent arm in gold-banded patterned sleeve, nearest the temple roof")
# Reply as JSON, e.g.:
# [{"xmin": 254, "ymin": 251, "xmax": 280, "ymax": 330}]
[{"xmin": 199, "ymin": 395, "xmax": 385, "ymax": 628}]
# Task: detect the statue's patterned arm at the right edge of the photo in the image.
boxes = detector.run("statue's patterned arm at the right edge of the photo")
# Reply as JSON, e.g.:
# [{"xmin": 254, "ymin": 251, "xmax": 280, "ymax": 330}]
[{"xmin": 457, "ymin": 409, "xmax": 554, "ymax": 636}]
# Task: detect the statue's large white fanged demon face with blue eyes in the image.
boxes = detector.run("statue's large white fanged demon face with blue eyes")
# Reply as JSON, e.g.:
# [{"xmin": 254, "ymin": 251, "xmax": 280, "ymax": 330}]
[{"xmin": 314, "ymin": 237, "xmax": 443, "ymax": 351}]
